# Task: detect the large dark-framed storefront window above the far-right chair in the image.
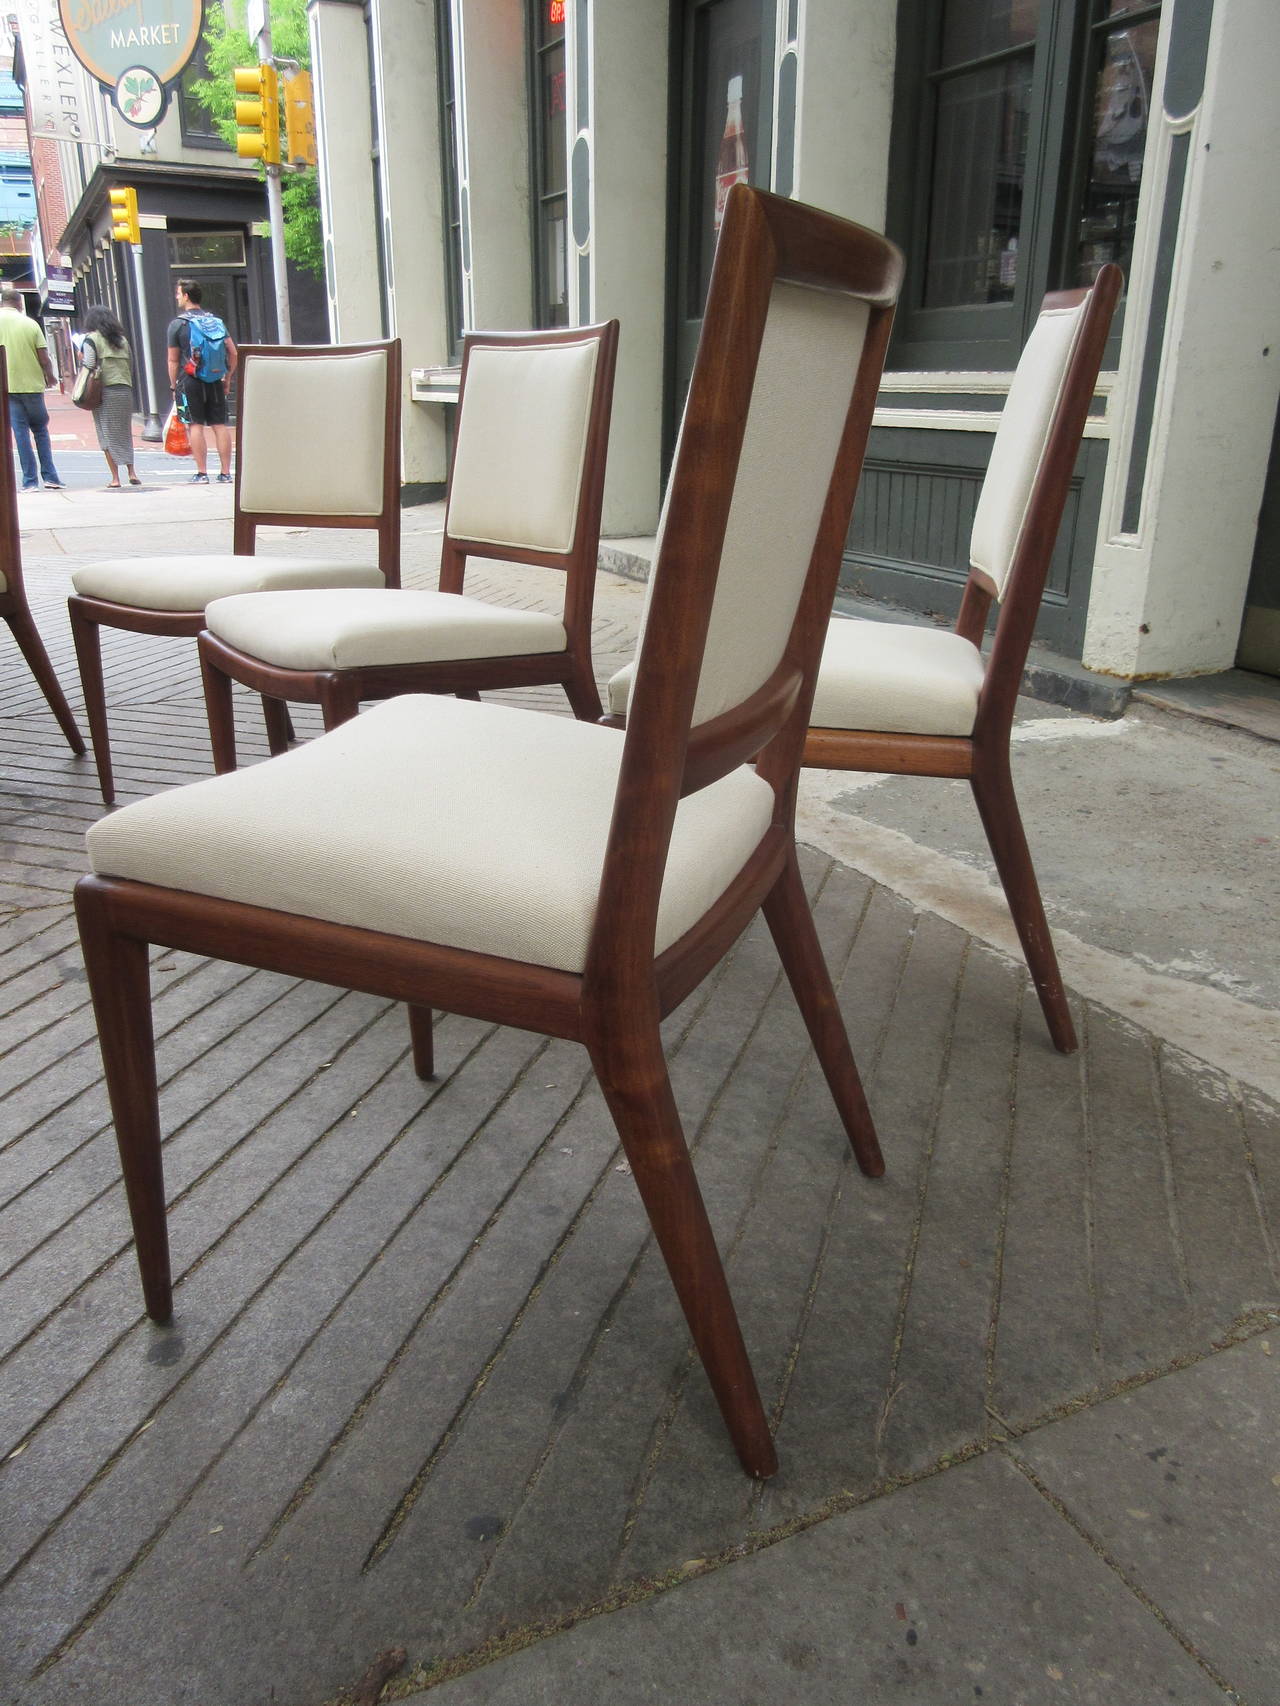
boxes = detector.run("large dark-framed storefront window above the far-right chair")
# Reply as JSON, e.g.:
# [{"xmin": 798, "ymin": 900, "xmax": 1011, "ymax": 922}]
[{"xmin": 891, "ymin": 0, "xmax": 1161, "ymax": 368}]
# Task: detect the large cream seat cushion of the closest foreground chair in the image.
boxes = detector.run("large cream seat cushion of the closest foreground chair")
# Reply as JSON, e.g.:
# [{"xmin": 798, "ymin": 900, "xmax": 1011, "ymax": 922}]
[{"xmin": 89, "ymin": 694, "xmax": 773, "ymax": 971}]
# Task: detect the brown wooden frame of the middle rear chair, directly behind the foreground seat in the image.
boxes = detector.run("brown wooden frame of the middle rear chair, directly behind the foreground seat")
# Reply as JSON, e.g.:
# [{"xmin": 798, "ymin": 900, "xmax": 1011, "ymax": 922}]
[{"xmin": 200, "ymin": 321, "xmax": 618, "ymax": 775}]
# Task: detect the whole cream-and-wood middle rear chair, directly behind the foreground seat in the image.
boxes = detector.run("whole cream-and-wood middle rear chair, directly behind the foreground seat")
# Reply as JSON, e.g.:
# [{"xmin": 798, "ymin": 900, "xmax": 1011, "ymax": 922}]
[{"xmin": 200, "ymin": 321, "xmax": 618, "ymax": 771}]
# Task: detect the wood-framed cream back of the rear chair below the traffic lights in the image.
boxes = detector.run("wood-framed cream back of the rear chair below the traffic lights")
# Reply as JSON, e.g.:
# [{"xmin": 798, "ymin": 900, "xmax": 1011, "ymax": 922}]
[{"xmin": 232, "ymin": 338, "xmax": 403, "ymax": 587}]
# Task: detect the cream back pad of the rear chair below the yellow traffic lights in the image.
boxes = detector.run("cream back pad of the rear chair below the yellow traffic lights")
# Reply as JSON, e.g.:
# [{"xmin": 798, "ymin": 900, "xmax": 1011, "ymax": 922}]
[{"xmin": 239, "ymin": 350, "xmax": 389, "ymax": 515}]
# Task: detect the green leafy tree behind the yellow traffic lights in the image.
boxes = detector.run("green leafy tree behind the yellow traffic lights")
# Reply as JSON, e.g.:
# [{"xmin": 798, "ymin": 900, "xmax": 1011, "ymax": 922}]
[{"xmin": 188, "ymin": 0, "xmax": 324, "ymax": 278}]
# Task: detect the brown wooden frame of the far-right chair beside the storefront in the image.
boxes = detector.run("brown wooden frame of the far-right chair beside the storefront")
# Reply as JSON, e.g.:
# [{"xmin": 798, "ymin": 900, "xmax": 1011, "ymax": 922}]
[{"xmin": 804, "ymin": 264, "xmax": 1123, "ymax": 1054}]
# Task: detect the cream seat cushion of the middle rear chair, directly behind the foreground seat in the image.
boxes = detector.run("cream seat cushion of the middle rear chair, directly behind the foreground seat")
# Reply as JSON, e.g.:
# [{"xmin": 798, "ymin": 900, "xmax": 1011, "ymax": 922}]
[{"xmin": 205, "ymin": 587, "xmax": 568, "ymax": 670}]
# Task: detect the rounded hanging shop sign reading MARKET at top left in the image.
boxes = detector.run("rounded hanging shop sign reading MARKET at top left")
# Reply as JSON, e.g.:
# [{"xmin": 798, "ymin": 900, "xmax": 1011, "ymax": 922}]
[{"xmin": 58, "ymin": 0, "xmax": 205, "ymax": 130}]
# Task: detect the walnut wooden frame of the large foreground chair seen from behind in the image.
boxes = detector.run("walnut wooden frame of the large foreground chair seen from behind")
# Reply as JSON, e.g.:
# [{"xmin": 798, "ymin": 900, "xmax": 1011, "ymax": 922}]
[{"xmin": 77, "ymin": 184, "xmax": 901, "ymax": 1477}]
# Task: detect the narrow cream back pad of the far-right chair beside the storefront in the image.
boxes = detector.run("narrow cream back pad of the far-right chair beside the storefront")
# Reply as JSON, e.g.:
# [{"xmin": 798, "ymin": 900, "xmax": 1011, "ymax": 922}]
[{"xmin": 969, "ymin": 299, "xmax": 1087, "ymax": 597}]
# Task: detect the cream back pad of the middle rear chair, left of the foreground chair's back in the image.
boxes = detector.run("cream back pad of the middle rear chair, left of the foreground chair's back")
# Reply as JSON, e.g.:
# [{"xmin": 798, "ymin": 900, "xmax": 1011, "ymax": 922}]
[{"xmin": 445, "ymin": 338, "xmax": 599, "ymax": 553}]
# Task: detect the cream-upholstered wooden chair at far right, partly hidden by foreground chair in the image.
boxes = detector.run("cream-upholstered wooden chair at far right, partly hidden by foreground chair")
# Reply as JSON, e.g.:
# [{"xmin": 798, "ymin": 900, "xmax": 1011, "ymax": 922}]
[{"xmin": 804, "ymin": 264, "xmax": 1123, "ymax": 1054}]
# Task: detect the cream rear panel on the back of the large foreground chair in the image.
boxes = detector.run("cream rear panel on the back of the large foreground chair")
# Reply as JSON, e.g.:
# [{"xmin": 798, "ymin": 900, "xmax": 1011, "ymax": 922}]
[{"xmin": 672, "ymin": 283, "xmax": 870, "ymax": 727}]
